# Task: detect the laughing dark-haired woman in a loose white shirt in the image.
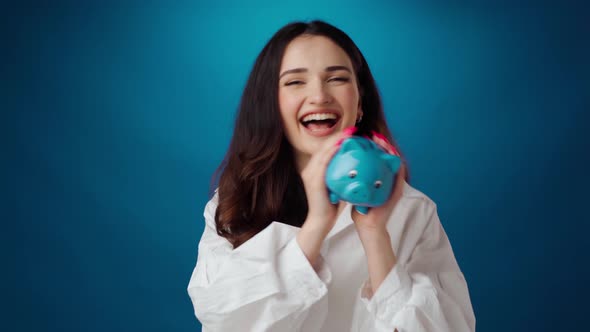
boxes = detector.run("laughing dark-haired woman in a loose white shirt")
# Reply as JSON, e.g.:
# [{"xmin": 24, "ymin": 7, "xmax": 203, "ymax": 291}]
[{"xmin": 188, "ymin": 21, "xmax": 475, "ymax": 332}]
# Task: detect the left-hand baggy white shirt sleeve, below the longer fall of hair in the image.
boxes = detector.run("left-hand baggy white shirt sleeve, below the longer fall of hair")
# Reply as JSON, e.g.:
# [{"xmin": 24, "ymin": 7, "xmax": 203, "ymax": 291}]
[{"xmin": 188, "ymin": 198, "xmax": 331, "ymax": 331}]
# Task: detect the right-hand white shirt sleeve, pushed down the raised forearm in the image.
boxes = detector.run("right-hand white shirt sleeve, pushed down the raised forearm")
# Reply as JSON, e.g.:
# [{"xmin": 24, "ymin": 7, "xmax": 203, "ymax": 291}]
[{"xmin": 352, "ymin": 201, "xmax": 475, "ymax": 332}]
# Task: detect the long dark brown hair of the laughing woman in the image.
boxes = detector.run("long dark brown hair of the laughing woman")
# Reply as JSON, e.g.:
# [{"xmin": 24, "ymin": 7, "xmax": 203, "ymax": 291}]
[{"xmin": 211, "ymin": 21, "xmax": 407, "ymax": 248}]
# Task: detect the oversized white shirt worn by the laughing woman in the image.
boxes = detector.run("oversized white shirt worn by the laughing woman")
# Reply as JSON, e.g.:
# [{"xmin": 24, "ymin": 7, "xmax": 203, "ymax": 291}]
[{"xmin": 188, "ymin": 183, "xmax": 475, "ymax": 332}]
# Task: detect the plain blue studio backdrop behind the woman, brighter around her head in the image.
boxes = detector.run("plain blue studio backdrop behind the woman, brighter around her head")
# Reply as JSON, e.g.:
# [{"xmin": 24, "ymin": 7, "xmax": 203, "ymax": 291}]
[{"xmin": 6, "ymin": 1, "xmax": 590, "ymax": 331}]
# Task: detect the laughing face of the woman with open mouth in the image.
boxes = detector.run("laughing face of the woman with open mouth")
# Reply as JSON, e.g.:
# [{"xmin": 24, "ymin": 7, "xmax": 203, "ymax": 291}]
[{"xmin": 279, "ymin": 35, "xmax": 362, "ymax": 167}]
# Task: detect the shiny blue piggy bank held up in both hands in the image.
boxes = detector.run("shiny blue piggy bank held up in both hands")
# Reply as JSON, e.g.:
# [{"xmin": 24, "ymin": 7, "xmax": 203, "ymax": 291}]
[{"xmin": 326, "ymin": 136, "xmax": 401, "ymax": 214}]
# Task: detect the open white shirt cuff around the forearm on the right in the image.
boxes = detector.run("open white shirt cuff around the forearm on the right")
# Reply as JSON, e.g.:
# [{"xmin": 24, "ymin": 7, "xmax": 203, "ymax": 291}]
[{"xmin": 360, "ymin": 263, "xmax": 412, "ymax": 321}]
